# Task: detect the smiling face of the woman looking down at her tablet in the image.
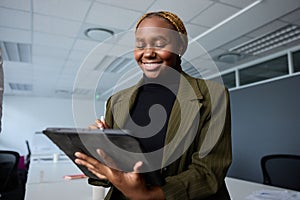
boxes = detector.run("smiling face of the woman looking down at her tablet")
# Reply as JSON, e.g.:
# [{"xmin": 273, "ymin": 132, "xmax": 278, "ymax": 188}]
[{"xmin": 134, "ymin": 16, "xmax": 181, "ymax": 78}]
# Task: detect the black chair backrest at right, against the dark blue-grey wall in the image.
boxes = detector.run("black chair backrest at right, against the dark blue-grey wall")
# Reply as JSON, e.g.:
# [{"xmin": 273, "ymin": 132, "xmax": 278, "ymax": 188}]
[{"xmin": 261, "ymin": 154, "xmax": 300, "ymax": 191}]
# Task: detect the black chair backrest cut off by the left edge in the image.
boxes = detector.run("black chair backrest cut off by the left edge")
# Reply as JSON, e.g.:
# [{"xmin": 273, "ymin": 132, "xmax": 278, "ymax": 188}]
[{"xmin": 0, "ymin": 151, "xmax": 20, "ymax": 193}]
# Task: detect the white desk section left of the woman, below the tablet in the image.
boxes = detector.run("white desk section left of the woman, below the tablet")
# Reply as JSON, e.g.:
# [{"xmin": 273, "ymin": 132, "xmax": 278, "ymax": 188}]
[{"xmin": 25, "ymin": 158, "xmax": 105, "ymax": 200}]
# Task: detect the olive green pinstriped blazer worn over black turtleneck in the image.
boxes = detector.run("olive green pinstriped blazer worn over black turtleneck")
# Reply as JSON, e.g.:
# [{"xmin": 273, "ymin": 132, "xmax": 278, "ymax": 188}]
[{"xmin": 89, "ymin": 72, "xmax": 232, "ymax": 200}]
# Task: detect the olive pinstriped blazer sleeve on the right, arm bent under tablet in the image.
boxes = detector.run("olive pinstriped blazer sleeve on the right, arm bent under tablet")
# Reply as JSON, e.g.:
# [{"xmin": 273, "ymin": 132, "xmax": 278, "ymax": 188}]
[{"xmin": 162, "ymin": 85, "xmax": 232, "ymax": 200}]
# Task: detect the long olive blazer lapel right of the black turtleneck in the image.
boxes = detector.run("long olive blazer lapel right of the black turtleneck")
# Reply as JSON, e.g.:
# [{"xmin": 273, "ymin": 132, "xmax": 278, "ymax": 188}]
[{"xmin": 162, "ymin": 73, "xmax": 203, "ymax": 166}]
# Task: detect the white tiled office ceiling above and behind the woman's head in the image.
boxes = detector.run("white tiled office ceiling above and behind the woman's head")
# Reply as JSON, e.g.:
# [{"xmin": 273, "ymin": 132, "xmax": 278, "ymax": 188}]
[{"xmin": 0, "ymin": 0, "xmax": 300, "ymax": 99}]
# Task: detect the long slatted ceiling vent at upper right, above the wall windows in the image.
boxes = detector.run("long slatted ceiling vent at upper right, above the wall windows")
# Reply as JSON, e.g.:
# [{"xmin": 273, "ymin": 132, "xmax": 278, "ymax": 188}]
[{"xmin": 229, "ymin": 24, "xmax": 300, "ymax": 55}]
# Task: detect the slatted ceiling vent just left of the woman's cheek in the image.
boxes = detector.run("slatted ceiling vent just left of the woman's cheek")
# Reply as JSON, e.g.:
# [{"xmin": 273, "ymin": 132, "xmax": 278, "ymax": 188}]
[{"xmin": 94, "ymin": 56, "xmax": 134, "ymax": 73}]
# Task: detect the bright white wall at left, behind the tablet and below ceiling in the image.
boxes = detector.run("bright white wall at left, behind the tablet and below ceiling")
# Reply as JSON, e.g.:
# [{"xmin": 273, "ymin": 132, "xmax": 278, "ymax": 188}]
[{"xmin": 0, "ymin": 96, "xmax": 104, "ymax": 155}]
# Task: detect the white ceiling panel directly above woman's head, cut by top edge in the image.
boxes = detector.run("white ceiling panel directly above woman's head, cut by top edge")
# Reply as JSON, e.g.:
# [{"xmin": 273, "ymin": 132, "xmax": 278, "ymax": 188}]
[{"xmin": 149, "ymin": 0, "xmax": 212, "ymax": 21}]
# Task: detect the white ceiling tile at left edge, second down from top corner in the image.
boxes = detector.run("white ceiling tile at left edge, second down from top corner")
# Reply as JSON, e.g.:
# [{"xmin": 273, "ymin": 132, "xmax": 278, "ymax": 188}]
[{"xmin": 0, "ymin": 8, "xmax": 31, "ymax": 30}]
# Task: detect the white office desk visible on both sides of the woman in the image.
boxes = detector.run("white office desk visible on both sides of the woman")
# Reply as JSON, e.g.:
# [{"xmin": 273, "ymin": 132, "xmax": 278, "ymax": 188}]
[{"xmin": 25, "ymin": 159, "xmax": 300, "ymax": 200}]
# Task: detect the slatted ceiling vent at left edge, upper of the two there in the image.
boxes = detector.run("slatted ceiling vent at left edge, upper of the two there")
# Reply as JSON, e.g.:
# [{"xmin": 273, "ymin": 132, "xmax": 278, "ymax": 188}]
[{"xmin": 0, "ymin": 41, "xmax": 32, "ymax": 63}]
